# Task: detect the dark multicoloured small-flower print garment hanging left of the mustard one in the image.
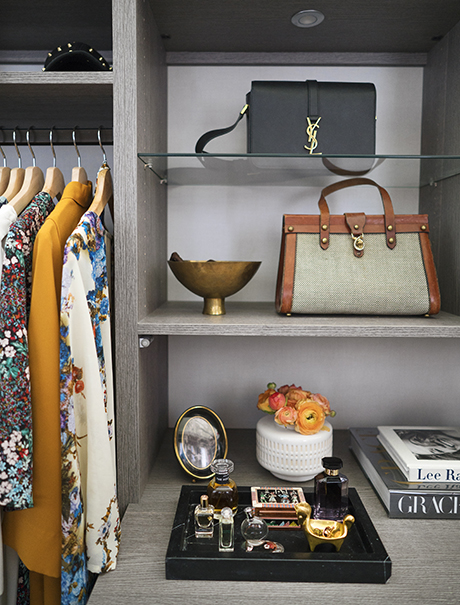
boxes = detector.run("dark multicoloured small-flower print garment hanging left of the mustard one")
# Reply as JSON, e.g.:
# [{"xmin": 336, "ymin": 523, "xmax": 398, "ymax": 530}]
[{"xmin": 0, "ymin": 193, "xmax": 54, "ymax": 509}]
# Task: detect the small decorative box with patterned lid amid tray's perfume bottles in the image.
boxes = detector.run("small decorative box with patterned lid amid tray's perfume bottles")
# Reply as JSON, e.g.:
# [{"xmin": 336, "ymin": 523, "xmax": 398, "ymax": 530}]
[{"xmin": 251, "ymin": 487, "xmax": 305, "ymax": 529}]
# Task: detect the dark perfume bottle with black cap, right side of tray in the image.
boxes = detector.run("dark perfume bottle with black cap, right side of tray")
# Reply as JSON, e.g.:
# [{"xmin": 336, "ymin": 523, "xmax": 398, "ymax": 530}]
[{"xmin": 313, "ymin": 456, "xmax": 348, "ymax": 521}]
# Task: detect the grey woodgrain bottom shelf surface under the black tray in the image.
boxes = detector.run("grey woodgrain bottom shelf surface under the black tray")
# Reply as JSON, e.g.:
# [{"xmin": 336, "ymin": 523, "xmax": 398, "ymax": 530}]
[{"xmin": 90, "ymin": 429, "xmax": 460, "ymax": 605}]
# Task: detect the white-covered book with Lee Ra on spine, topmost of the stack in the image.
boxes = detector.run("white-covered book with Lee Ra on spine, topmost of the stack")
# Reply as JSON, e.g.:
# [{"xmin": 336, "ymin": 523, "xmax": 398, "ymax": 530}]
[{"xmin": 377, "ymin": 426, "xmax": 460, "ymax": 483}]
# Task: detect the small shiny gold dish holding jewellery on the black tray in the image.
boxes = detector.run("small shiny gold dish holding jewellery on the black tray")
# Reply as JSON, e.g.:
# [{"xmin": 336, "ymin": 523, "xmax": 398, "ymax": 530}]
[{"xmin": 295, "ymin": 502, "xmax": 355, "ymax": 552}]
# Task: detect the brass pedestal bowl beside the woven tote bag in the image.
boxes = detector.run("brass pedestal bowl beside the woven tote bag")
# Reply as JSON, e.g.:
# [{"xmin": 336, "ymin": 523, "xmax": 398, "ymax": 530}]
[{"xmin": 168, "ymin": 255, "xmax": 261, "ymax": 315}]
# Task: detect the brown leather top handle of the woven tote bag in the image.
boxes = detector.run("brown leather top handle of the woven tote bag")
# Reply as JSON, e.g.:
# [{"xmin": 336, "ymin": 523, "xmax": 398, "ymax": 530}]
[{"xmin": 318, "ymin": 178, "xmax": 396, "ymax": 249}]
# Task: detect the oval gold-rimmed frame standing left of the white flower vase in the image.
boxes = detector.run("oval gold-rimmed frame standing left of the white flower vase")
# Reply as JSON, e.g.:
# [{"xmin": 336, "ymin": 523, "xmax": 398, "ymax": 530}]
[{"xmin": 174, "ymin": 406, "xmax": 228, "ymax": 479}]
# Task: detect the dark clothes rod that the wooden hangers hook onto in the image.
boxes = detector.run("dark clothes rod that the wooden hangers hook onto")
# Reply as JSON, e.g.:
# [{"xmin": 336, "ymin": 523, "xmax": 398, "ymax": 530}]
[{"xmin": 0, "ymin": 126, "xmax": 113, "ymax": 147}]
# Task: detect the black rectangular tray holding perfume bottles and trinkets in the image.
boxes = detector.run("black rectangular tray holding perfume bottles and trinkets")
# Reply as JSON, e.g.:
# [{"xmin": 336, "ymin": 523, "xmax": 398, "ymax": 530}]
[{"xmin": 166, "ymin": 485, "xmax": 391, "ymax": 584}]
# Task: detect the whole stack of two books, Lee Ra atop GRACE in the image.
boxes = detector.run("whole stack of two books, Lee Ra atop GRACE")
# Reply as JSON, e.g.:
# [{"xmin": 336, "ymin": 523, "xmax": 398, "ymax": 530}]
[{"xmin": 350, "ymin": 426, "xmax": 460, "ymax": 519}]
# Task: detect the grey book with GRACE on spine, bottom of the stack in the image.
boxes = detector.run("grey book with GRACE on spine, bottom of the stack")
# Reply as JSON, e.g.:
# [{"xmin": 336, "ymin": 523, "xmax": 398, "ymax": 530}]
[{"xmin": 350, "ymin": 427, "xmax": 460, "ymax": 519}]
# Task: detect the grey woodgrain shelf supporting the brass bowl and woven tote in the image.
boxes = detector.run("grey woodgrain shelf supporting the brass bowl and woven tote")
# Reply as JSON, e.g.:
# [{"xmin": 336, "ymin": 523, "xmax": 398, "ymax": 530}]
[{"xmin": 138, "ymin": 301, "xmax": 460, "ymax": 338}]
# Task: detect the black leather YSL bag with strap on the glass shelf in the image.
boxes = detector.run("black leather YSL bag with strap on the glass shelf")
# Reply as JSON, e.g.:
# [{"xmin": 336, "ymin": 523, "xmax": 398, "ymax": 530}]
[{"xmin": 195, "ymin": 80, "xmax": 376, "ymax": 155}]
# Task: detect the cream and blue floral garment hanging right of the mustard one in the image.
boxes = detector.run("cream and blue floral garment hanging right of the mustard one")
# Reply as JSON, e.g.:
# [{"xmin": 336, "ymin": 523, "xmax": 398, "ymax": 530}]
[{"xmin": 60, "ymin": 211, "xmax": 120, "ymax": 605}]
